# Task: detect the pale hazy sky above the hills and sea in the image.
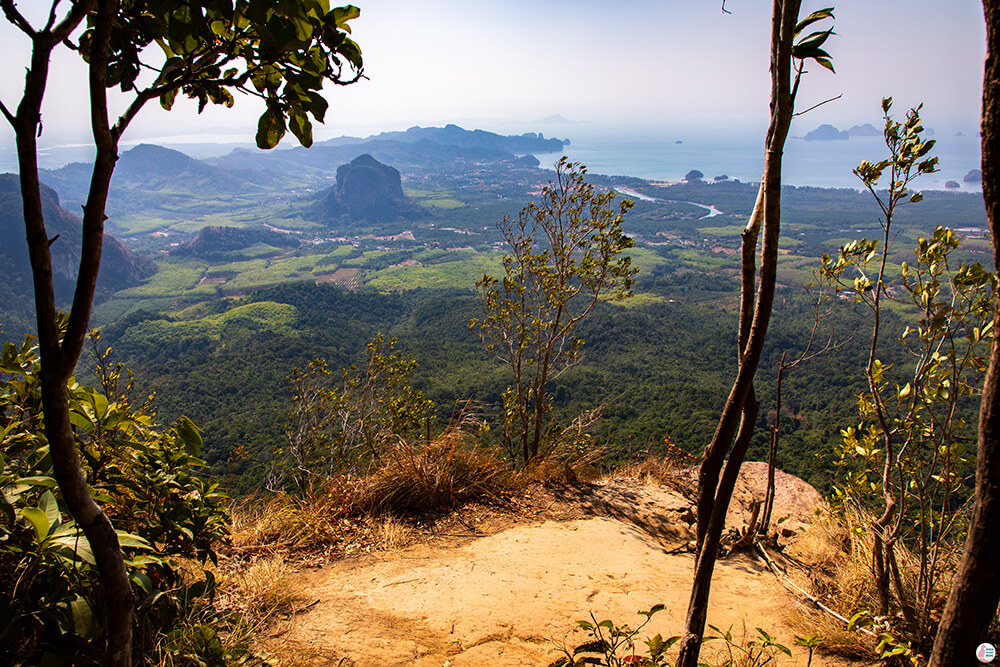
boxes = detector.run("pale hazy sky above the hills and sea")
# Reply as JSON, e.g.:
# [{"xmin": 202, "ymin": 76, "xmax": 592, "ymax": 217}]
[{"xmin": 0, "ymin": 0, "xmax": 985, "ymax": 158}]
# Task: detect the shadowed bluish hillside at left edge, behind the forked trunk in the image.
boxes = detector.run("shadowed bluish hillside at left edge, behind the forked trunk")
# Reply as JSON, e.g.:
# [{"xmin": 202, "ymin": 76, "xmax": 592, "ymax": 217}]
[{"xmin": 0, "ymin": 174, "xmax": 156, "ymax": 307}]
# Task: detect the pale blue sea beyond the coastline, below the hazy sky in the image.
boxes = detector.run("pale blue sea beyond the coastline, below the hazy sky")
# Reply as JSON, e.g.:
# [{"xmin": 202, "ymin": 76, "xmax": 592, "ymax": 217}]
[{"xmin": 536, "ymin": 126, "xmax": 981, "ymax": 192}]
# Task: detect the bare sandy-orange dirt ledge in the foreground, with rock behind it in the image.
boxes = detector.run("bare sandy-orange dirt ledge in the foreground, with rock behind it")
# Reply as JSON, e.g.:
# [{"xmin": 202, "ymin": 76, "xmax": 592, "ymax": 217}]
[{"xmin": 267, "ymin": 466, "xmax": 856, "ymax": 667}]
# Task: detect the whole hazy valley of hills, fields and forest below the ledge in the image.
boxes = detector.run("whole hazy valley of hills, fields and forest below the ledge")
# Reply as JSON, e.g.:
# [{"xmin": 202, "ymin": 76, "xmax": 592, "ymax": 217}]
[{"xmin": 3, "ymin": 126, "xmax": 988, "ymax": 490}]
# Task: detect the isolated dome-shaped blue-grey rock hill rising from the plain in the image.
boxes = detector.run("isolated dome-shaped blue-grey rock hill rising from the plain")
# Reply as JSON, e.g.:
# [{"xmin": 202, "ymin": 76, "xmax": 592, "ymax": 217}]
[{"xmin": 313, "ymin": 154, "xmax": 410, "ymax": 223}]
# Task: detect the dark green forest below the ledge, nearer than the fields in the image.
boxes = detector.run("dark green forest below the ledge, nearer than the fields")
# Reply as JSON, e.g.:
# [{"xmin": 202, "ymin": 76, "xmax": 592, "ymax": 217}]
[{"xmin": 97, "ymin": 273, "xmax": 902, "ymax": 494}]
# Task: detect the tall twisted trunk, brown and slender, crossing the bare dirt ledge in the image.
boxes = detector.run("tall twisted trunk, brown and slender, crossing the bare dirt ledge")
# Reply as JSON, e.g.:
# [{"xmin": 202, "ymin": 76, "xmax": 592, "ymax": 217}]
[{"xmin": 677, "ymin": 0, "xmax": 801, "ymax": 667}]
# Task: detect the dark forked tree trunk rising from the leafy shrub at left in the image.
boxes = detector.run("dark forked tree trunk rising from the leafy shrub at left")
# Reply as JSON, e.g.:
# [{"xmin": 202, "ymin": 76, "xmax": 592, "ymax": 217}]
[{"xmin": 14, "ymin": 0, "xmax": 133, "ymax": 667}]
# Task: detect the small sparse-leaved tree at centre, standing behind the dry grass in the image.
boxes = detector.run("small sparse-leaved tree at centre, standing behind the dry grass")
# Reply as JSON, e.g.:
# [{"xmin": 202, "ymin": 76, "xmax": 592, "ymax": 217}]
[{"xmin": 469, "ymin": 158, "xmax": 637, "ymax": 467}]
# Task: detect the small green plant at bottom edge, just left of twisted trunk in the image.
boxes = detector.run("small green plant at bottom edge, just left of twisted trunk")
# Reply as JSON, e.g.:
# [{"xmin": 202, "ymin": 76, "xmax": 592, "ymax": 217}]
[{"xmin": 549, "ymin": 604, "xmax": 680, "ymax": 667}]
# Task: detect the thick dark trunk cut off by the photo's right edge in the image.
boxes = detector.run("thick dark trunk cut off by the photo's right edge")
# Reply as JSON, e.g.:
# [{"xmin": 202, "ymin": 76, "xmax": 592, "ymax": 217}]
[{"xmin": 930, "ymin": 0, "xmax": 1000, "ymax": 667}]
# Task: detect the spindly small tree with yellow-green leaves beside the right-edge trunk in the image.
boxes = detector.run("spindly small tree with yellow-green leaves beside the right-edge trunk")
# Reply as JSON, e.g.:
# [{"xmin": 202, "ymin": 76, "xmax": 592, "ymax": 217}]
[{"xmin": 822, "ymin": 98, "xmax": 995, "ymax": 643}]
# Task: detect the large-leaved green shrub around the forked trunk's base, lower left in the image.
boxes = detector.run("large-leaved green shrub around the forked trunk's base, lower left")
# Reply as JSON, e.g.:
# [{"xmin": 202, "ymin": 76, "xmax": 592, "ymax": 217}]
[{"xmin": 0, "ymin": 336, "xmax": 249, "ymax": 664}]
